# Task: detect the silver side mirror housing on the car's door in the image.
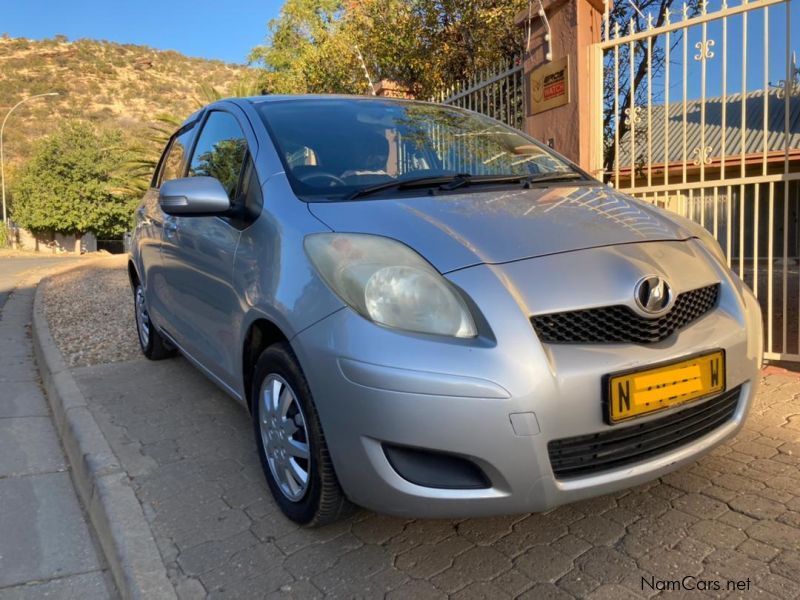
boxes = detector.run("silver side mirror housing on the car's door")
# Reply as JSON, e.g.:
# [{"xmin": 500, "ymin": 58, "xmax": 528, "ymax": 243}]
[{"xmin": 158, "ymin": 177, "xmax": 231, "ymax": 216}]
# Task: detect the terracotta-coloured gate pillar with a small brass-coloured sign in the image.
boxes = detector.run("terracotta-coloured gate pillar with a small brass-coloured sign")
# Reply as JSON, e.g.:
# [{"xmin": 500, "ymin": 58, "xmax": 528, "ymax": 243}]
[{"xmin": 516, "ymin": 0, "xmax": 604, "ymax": 172}]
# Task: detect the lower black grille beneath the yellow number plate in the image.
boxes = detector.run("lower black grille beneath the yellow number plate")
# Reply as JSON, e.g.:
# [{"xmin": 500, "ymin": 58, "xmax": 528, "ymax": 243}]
[{"xmin": 547, "ymin": 388, "xmax": 741, "ymax": 479}]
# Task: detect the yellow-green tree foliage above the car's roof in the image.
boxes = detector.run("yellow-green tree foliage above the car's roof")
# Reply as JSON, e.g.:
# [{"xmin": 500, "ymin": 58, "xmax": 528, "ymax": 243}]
[{"xmin": 250, "ymin": 0, "xmax": 527, "ymax": 97}]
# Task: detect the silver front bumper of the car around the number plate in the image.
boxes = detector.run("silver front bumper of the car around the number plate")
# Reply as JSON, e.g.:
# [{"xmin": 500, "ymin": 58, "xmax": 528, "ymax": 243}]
[{"xmin": 292, "ymin": 241, "xmax": 761, "ymax": 517}]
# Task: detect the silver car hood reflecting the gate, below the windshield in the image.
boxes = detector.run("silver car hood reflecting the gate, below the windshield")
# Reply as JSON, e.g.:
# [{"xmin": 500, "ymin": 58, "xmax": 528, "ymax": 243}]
[{"xmin": 309, "ymin": 185, "xmax": 692, "ymax": 273}]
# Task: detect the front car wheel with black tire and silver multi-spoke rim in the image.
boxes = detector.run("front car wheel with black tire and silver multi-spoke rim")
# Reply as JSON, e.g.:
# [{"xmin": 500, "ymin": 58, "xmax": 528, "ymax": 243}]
[{"xmin": 252, "ymin": 343, "xmax": 354, "ymax": 527}]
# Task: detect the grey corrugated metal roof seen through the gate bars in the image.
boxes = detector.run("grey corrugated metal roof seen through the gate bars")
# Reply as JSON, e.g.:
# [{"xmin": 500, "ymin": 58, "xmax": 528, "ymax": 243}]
[{"xmin": 619, "ymin": 90, "xmax": 800, "ymax": 169}]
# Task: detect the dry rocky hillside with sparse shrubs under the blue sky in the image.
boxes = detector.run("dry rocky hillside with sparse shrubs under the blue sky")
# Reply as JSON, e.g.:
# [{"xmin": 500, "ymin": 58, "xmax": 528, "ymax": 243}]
[{"xmin": 0, "ymin": 36, "xmax": 249, "ymax": 167}]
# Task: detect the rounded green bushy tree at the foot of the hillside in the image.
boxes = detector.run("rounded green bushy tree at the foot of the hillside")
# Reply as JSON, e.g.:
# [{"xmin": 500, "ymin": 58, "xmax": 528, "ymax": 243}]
[{"xmin": 11, "ymin": 122, "xmax": 136, "ymax": 245}]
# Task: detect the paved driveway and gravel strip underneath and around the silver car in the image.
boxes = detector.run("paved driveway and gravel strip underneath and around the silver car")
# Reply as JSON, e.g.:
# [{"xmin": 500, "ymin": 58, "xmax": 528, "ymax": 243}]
[{"xmin": 45, "ymin": 262, "xmax": 800, "ymax": 600}]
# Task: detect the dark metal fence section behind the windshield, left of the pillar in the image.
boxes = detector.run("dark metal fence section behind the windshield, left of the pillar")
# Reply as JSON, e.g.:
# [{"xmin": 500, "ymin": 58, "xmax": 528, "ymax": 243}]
[{"xmin": 433, "ymin": 56, "xmax": 525, "ymax": 129}]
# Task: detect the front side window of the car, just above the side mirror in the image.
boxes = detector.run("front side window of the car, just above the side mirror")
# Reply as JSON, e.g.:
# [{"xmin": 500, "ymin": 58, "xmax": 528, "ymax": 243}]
[{"xmin": 189, "ymin": 111, "xmax": 247, "ymax": 202}]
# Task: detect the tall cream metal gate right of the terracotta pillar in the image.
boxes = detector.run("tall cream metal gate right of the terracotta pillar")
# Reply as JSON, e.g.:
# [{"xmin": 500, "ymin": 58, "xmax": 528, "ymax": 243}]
[{"xmin": 595, "ymin": 0, "xmax": 800, "ymax": 361}]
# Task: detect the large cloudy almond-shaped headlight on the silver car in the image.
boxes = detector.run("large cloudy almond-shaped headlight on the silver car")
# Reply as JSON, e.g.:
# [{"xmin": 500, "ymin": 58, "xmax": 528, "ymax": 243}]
[{"xmin": 304, "ymin": 233, "xmax": 477, "ymax": 338}]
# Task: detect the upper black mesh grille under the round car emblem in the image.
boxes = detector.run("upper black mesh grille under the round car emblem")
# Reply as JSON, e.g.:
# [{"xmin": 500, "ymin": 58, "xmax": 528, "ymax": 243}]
[{"xmin": 531, "ymin": 283, "xmax": 719, "ymax": 344}]
